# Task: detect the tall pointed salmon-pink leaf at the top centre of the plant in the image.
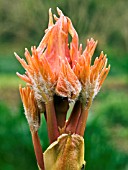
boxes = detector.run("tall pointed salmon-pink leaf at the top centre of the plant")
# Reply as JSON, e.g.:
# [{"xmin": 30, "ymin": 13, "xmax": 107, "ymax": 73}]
[{"xmin": 37, "ymin": 8, "xmax": 79, "ymax": 74}]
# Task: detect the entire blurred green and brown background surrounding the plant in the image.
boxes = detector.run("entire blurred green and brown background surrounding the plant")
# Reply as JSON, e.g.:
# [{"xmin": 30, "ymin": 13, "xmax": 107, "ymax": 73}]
[{"xmin": 0, "ymin": 0, "xmax": 128, "ymax": 170}]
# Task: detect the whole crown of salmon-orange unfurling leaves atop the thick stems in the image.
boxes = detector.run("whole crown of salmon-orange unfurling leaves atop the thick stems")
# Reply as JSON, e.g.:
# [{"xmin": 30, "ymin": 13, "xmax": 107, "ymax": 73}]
[{"xmin": 15, "ymin": 8, "xmax": 110, "ymax": 105}]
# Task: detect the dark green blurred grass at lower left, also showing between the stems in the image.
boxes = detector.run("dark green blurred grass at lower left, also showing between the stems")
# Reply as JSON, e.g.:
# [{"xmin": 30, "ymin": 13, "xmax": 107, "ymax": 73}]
[{"xmin": 0, "ymin": 102, "xmax": 48, "ymax": 170}]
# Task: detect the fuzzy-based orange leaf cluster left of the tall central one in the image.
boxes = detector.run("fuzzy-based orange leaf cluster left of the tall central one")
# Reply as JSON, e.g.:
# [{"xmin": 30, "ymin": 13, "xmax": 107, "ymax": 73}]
[{"xmin": 15, "ymin": 47, "xmax": 56, "ymax": 103}]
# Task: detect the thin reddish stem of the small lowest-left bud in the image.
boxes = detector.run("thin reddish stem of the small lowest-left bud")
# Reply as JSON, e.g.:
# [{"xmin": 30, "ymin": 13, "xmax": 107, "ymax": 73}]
[{"xmin": 31, "ymin": 131, "xmax": 45, "ymax": 170}]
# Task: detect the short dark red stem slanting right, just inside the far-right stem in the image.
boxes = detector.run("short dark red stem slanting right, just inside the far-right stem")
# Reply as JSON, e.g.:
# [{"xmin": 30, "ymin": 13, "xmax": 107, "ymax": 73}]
[{"xmin": 66, "ymin": 101, "xmax": 81, "ymax": 133}]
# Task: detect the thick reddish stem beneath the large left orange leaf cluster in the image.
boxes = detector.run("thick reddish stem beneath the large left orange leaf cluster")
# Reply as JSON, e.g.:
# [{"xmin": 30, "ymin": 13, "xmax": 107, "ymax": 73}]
[{"xmin": 45, "ymin": 100, "xmax": 59, "ymax": 143}]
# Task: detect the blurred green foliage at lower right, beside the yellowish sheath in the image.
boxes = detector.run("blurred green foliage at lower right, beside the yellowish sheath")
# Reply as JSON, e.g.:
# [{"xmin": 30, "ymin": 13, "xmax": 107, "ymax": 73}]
[{"xmin": 85, "ymin": 89, "xmax": 128, "ymax": 170}]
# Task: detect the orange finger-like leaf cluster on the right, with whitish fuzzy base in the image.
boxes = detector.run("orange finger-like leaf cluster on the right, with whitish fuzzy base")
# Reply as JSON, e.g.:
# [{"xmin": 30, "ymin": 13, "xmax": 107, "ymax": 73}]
[{"xmin": 73, "ymin": 38, "xmax": 110, "ymax": 104}]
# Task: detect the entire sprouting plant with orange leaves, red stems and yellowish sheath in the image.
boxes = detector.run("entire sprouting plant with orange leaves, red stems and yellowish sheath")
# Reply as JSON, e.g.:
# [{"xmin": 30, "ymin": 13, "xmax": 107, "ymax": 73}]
[{"xmin": 15, "ymin": 8, "xmax": 110, "ymax": 170}]
